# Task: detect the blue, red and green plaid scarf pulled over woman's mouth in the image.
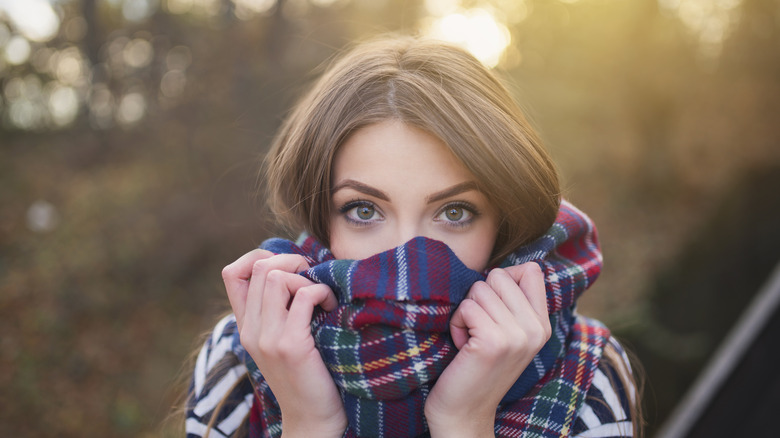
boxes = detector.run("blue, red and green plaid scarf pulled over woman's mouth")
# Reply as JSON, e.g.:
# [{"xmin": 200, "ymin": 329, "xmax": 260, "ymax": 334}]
[{"xmin": 233, "ymin": 201, "xmax": 609, "ymax": 437}]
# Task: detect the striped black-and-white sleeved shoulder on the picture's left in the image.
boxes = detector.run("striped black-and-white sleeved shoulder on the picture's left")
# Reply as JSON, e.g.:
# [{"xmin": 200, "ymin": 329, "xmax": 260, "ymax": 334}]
[{"xmin": 185, "ymin": 314, "xmax": 254, "ymax": 438}]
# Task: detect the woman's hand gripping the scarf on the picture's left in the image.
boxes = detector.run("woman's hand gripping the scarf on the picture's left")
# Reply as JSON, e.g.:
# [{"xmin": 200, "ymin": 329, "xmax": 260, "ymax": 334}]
[{"xmin": 222, "ymin": 249, "xmax": 347, "ymax": 437}]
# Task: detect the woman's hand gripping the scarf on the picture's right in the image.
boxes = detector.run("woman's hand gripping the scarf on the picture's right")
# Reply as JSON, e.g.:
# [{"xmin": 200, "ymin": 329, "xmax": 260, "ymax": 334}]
[{"xmin": 425, "ymin": 262, "xmax": 552, "ymax": 437}]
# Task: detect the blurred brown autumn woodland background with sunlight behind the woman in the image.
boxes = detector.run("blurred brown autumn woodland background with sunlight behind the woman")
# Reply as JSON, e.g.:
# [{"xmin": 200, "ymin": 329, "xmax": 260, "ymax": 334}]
[{"xmin": 0, "ymin": 0, "xmax": 780, "ymax": 437}]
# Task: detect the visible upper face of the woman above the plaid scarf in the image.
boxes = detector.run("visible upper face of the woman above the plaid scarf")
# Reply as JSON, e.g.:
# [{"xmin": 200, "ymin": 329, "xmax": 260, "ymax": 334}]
[{"xmin": 329, "ymin": 120, "xmax": 498, "ymax": 271}]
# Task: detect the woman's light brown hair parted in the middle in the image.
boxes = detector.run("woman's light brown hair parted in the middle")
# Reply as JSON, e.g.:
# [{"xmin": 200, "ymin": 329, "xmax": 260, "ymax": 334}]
[{"xmin": 265, "ymin": 37, "xmax": 560, "ymax": 263}]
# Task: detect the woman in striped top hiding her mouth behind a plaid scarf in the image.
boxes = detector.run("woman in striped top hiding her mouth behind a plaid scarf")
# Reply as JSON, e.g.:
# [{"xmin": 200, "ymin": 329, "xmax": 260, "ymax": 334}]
[{"xmin": 187, "ymin": 38, "xmax": 638, "ymax": 437}]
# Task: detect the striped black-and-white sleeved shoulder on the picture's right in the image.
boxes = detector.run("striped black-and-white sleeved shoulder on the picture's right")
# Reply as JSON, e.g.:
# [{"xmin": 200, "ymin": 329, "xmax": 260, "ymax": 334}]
[{"xmin": 572, "ymin": 337, "xmax": 636, "ymax": 438}]
